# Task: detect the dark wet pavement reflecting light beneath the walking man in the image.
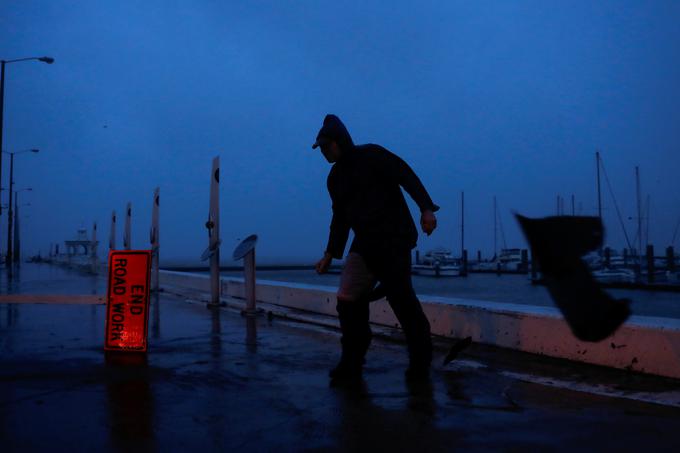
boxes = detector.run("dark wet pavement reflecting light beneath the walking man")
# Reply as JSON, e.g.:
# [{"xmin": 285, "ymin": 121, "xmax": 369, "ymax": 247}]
[{"xmin": 0, "ymin": 264, "xmax": 680, "ymax": 452}]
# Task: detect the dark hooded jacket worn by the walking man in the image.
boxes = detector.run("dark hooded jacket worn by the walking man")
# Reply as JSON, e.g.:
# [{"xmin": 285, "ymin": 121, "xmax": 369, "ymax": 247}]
[{"xmin": 317, "ymin": 115, "xmax": 439, "ymax": 259}]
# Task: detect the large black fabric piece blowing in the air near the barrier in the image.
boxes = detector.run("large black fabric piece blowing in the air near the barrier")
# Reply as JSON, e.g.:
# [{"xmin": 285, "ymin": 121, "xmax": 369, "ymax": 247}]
[{"xmin": 516, "ymin": 214, "xmax": 630, "ymax": 342}]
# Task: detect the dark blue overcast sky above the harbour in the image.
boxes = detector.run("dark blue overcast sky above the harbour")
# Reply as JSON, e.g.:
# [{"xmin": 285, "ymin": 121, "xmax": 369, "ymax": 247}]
[{"xmin": 0, "ymin": 0, "xmax": 680, "ymax": 264}]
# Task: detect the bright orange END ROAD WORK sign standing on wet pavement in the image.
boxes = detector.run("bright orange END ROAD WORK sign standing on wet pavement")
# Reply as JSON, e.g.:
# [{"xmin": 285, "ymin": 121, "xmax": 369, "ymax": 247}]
[{"xmin": 104, "ymin": 250, "xmax": 151, "ymax": 352}]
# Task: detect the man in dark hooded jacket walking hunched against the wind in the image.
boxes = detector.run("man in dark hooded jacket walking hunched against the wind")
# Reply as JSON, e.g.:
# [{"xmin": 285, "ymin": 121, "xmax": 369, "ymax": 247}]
[{"xmin": 312, "ymin": 111, "xmax": 439, "ymax": 380}]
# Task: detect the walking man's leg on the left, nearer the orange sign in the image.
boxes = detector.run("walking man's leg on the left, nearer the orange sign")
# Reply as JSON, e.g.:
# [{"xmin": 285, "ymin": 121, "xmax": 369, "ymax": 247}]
[{"xmin": 330, "ymin": 253, "xmax": 376, "ymax": 378}]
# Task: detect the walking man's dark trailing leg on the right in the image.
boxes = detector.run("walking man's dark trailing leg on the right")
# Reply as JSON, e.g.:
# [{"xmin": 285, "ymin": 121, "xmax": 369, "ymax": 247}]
[{"xmin": 367, "ymin": 250, "xmax": 432, "ymax": 377}]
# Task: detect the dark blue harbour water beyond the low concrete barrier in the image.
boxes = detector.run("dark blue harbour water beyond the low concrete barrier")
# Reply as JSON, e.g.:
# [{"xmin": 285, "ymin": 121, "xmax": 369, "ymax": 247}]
[{"xmin": 222, "ymin": 270, "xmax": 680, "ymax": 318}]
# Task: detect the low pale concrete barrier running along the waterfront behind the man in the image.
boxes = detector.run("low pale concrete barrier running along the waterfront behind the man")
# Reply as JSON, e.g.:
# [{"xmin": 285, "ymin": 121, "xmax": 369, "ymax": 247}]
[{"xmin": 161, "ymin": 271, "xmax": 680, "ymax": 378}]
